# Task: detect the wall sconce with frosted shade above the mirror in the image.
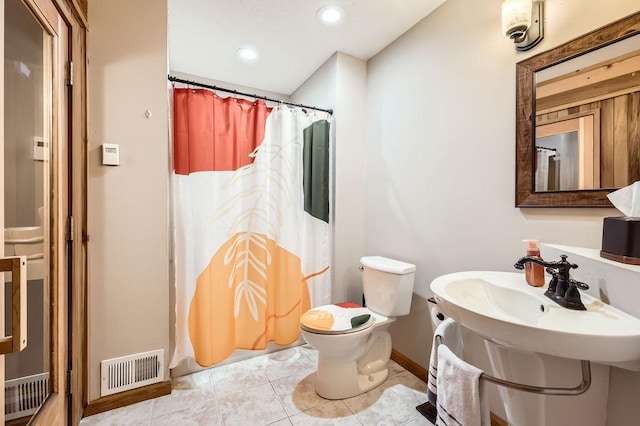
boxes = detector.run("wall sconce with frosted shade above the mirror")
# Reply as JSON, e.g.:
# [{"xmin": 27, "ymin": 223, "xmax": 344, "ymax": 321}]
[{"xmin": 502, "ymin": 0, "xmax": 544, "ymax": 51}]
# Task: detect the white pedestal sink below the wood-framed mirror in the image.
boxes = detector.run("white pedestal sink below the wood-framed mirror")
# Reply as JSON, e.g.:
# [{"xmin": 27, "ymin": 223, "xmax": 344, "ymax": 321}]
[{"xmin": 431, "ymin": 271, "xmax": 640, "ymax": 426}]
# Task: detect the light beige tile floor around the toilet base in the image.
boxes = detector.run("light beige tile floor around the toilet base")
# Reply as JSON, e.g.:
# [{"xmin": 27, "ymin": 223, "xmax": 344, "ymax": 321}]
[{"xmin": 80, "ymin": 345, "xmax": 431, "ymax": 426}]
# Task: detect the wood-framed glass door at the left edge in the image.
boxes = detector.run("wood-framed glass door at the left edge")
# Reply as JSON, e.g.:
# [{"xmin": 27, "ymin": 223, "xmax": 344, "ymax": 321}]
[{"xmin": 0, "ymin": 0, "xmax": 72, "ymax": 425}]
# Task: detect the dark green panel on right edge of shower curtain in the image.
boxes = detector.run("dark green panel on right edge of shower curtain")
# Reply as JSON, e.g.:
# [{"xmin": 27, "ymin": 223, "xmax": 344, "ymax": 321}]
[{"xmin": 302, "ymin": 120, "xmax": 331, "ymax": 223}]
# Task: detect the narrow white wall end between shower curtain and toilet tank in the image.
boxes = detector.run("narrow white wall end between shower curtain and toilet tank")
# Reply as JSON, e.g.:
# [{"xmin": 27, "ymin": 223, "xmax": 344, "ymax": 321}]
[{"xmin": 291, "ymin": 52, "xmax": 367, "ymax": 303}]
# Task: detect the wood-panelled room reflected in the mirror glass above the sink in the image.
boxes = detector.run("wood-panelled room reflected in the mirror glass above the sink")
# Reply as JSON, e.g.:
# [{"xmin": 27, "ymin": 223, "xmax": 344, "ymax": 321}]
[{"xmin": 535, "ymin": 36, "xmax": 640, "ymax": 191}]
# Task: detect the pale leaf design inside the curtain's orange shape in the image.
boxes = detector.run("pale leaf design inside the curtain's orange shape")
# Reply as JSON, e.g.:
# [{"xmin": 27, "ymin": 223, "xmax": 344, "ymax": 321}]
[{"xmin": 224, "ymin": 232, "xmax": 271, "ymax": 321}]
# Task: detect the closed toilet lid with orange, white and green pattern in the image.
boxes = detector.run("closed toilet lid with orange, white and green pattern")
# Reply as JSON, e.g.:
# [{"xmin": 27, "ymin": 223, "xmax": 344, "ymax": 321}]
[{"xmin": 300, "ymin": 304, "xmax": 373, "ymax": 334}]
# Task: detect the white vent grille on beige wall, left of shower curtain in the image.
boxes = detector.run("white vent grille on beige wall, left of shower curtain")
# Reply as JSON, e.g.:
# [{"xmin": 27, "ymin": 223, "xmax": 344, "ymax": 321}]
[{"xmin": 100, "ymin": 349, "xmax": 164, "ymax": 396}]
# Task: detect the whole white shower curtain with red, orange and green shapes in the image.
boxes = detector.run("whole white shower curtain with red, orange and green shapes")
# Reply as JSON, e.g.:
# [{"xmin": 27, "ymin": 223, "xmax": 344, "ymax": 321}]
[{"xmin": 170, "ymin": 88, "xmax": 333, "ymax": 367}]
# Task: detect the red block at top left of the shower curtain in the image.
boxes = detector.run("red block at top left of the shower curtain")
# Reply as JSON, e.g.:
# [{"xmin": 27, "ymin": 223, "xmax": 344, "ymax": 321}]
[{"xmin": 173, "ymin": 89, "xmax": 271, "ymax": 175}]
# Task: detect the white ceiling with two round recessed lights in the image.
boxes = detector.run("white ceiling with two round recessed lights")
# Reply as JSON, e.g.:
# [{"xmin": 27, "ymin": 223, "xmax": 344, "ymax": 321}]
[{"xmin": 168, "ymin": 0, "xmax": 445, "ymax": 95}]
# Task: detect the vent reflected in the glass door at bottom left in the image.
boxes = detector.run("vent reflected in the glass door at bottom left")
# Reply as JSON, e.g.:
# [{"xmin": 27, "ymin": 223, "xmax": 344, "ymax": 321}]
[{"xmin": 4, "ymin": 373, "xmax": 49, "ymax": 420}]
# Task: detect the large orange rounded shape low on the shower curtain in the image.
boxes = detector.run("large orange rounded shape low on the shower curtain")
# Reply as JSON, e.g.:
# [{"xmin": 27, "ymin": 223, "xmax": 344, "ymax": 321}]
[{"xmin": 189, "ymin": 232, "xmax": 311, "ymax": 366}]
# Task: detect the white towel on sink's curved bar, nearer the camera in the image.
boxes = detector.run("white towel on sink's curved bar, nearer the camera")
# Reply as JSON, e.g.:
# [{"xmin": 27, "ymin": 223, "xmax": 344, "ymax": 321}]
[{"xmin": 436, "ymin": 345, "xmax": 490, "ymax": 426}]
